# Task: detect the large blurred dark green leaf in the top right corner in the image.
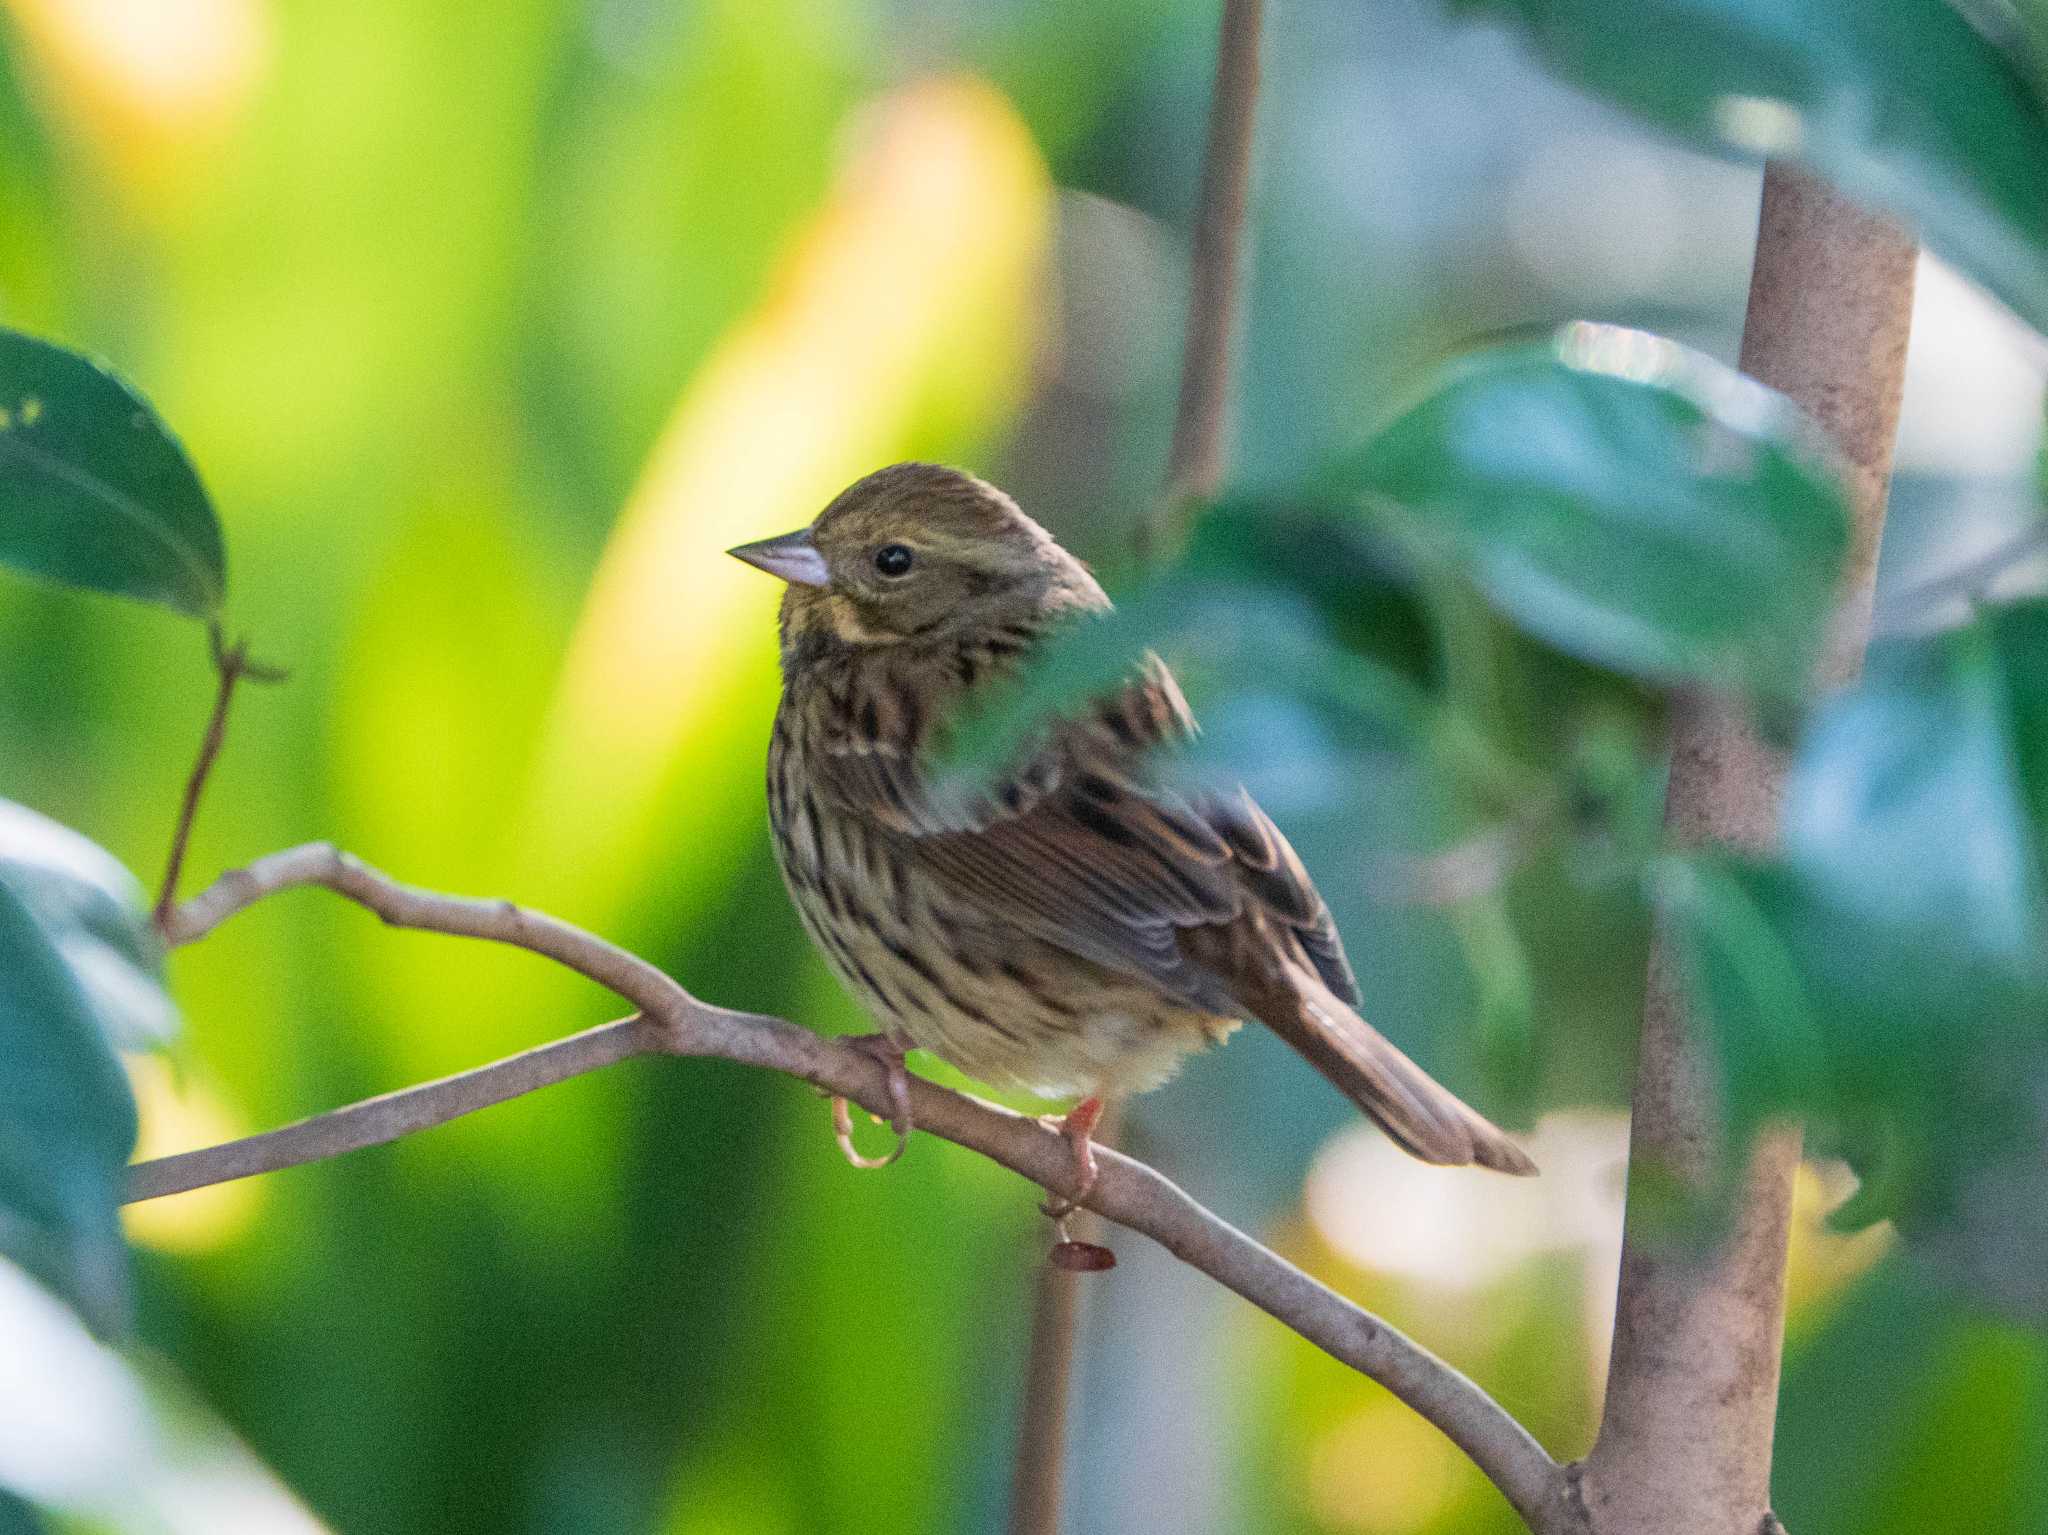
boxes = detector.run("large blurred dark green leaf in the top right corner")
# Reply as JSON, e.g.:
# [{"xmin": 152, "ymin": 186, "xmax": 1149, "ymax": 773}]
[{"xmin": 1450, "ymin": 0, "xmax": 2048, "ymax": 330}]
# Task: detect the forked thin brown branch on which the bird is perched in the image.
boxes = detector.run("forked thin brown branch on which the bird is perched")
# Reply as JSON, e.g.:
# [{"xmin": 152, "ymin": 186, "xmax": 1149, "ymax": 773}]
[{"xmin": 127, "ymin": 843, "xmax": 1573, "ymax": 1531}]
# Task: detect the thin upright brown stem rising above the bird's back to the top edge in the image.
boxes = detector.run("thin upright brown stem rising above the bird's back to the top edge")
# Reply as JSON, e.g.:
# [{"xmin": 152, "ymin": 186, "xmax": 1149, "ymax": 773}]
[{"xmin": 1137, "ymin": 0, "xmax": 1264, "ymax": 555}]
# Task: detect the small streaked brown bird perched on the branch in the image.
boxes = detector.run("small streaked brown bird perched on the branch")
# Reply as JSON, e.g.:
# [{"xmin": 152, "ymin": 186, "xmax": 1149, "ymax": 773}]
[{"xmin": 731, "ymin": 465, "xmax": 1536, "ymax": 1199}]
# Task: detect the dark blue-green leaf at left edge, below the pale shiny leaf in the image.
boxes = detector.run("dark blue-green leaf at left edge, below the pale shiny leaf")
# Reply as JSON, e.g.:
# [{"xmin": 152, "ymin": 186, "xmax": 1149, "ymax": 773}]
[{"xmin": 0, "ymin": 882, "xmax": 135, "ymax": 1330}]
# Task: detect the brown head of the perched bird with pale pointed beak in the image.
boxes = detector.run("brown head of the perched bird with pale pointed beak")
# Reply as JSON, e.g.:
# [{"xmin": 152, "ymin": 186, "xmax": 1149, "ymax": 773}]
[{"xmin": 729, "ymin": 465, "xmax": 1104, "ymax": 651}]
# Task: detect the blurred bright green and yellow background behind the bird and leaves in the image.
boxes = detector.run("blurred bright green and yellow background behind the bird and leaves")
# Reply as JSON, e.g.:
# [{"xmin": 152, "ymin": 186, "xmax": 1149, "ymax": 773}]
[{"xmin": 0, "ymin": 0, "xmax": 2048, "ymax": 1535}]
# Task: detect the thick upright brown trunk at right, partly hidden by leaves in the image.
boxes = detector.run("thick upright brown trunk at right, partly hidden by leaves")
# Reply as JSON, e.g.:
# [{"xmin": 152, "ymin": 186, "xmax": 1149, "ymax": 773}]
[{"xmin": 1579, "ymin": 166, "xmax": 1915, "ymax": 1535}]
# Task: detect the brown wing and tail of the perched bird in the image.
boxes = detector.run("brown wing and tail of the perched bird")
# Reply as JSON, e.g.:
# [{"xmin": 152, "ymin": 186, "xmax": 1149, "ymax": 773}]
[{"xmin": 825, "ymin": 659, "xmax": 1536, "ymax": 1173}]
